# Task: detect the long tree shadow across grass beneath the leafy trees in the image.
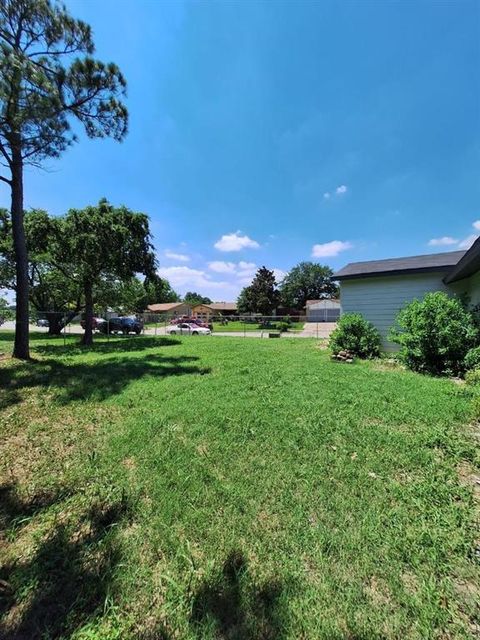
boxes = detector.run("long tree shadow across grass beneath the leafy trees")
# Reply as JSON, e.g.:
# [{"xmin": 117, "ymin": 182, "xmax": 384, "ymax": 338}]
[{"xmin": 0, "ymin": 353, "xmax": 210, "ymax": 409}]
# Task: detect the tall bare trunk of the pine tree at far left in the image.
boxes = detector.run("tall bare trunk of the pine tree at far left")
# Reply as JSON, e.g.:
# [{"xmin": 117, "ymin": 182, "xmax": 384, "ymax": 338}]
[{"xmin": 11, "ymin": 148, "xmax": 30, "ymax": 360}]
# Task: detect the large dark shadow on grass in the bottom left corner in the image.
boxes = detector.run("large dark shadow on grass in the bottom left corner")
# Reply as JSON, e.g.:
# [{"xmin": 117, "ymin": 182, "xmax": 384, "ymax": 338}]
[{"xmin": 0, "ymin": 487, "xmax": 133, "ymax": 640}]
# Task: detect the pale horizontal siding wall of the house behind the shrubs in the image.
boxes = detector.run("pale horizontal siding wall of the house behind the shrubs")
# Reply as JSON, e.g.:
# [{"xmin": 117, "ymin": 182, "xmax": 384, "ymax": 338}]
[{"xmin": 340, "ymin": 273, "xmax": 454, "ymax": 350}]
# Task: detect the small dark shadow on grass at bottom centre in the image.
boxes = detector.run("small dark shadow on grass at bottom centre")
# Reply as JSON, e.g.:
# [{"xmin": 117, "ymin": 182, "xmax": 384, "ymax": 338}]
[{"xmin": 190, "ymin": 551, "xmax": 286, "ymax": 640}]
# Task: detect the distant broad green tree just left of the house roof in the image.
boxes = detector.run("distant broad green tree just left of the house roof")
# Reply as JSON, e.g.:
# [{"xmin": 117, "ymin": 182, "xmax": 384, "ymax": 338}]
[{"xmin": 280, "ymin": 262, "xmax": 338, "ymax": 310}]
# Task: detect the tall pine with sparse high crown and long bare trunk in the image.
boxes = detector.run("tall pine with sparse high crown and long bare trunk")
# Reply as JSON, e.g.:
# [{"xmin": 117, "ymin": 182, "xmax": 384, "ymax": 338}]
[{"xmin": 0, "ymin": 0, "xmax": 127, "ymax": 359}]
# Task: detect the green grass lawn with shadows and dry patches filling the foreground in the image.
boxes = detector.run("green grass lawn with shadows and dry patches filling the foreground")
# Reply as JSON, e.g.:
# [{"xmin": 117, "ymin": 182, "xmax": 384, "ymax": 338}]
[{"xmin": 0, "ymin": 332, "xmax": 480, "ymax": 640}]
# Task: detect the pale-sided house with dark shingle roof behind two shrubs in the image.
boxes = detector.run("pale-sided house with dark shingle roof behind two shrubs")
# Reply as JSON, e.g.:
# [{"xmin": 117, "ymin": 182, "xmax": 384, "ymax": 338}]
[{"xmin": 333, "ymin": 238, "xmax": 480, "ymax": 349}]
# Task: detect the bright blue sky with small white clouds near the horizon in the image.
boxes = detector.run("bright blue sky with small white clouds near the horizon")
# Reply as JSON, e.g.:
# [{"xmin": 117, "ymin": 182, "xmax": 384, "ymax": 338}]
[{"xmin": 0, "ymin": 0, "xmax": 480, "ymax": 300}]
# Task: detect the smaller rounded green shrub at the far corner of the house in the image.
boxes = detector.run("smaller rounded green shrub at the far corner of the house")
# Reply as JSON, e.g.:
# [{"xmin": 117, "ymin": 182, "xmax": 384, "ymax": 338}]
[{"xmin": 329, "ymin": 313, "xmax": 381, "ymax": 358}]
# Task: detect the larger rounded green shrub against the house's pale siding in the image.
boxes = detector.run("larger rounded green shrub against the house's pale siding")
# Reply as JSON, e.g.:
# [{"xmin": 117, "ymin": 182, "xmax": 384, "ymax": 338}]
[{"xmin": 390, "ymin": 291, "xmax": 477, "ymax": 375}]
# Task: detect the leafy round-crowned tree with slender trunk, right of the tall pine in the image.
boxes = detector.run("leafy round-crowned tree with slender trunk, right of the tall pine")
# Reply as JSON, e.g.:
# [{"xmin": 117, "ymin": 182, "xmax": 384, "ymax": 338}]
[{"xmin": 48, "ymin": 200, "xmax": 155, "ymax": 345}]
